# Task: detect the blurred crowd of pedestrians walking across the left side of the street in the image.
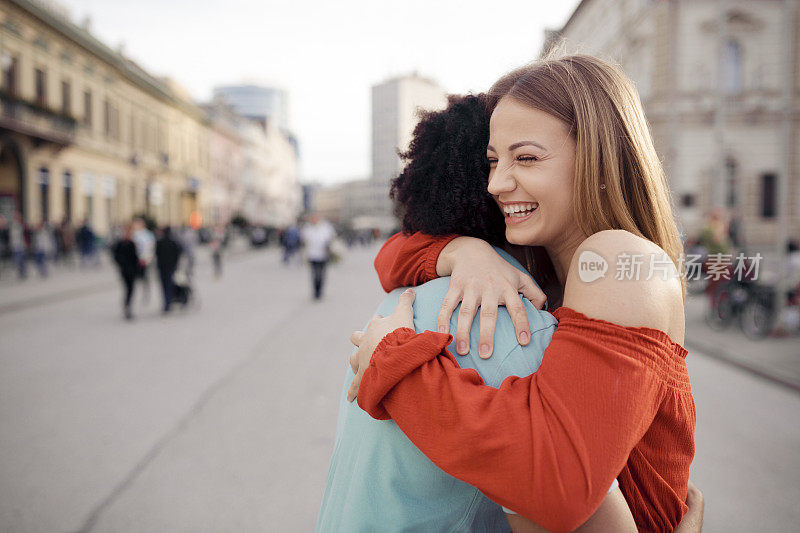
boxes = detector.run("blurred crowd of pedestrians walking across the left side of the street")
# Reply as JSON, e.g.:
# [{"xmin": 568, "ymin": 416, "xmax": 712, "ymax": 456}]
[{"xmin": 0, "ymin": 208, "xmax": 356, "ymax": 320}]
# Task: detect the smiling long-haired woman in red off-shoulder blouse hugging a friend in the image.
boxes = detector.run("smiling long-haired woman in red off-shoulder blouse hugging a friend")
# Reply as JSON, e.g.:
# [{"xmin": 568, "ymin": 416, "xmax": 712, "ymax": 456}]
[{"xmin": 350, "ymin": 56, "xmax": 695, "ymax": 531}]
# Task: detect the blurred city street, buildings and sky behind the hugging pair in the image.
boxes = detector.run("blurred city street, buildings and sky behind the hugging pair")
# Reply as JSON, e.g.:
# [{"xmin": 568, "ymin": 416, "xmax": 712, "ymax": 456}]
[{"xmin": 0, "ymin": 0, "xmax": 800, "ymax": 531}]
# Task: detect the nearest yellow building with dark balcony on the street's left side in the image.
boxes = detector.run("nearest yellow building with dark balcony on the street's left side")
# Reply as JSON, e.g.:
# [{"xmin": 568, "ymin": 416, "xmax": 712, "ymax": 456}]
[{"xmin": 0, "ymin": 0, "xmax": 216, "ymax": 233}]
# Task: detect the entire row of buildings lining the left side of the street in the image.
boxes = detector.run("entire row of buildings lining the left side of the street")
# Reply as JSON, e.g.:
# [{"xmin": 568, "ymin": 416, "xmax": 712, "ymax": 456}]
[{"xmin": 0, "ymin": 0, "xmax": 300, "ymax": 235}]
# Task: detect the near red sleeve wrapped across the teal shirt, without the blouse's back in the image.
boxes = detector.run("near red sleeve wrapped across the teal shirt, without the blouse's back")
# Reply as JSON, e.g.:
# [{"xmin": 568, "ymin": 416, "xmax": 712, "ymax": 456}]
[{"xmin": 359, "ymin": 326, "xmax": 659, "ymax": 530}]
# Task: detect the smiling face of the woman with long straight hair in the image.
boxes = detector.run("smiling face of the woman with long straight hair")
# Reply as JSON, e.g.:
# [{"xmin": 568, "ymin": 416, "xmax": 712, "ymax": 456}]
[{"xmin": 486, "ymin": 97, "xmax": 580, "ymax": 252}]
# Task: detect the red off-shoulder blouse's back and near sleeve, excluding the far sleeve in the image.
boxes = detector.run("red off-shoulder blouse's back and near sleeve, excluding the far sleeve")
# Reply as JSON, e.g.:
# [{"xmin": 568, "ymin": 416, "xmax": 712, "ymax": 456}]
[{"xmin": 358, "ymin": 307, "xmax": 695, "ymax": 531}]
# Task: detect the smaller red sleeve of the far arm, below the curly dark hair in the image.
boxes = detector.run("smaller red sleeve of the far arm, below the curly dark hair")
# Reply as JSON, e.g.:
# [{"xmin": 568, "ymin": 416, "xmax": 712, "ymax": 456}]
[{"xmin": 375, "ymin": 232, "xmax": 458, "ymax": 292}]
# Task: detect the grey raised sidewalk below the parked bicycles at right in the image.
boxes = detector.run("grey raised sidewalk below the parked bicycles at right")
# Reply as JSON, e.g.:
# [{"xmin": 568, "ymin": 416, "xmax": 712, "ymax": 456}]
[{"xmin": 686, "ymin": 295, "xmax": 800, "ymax": 392}]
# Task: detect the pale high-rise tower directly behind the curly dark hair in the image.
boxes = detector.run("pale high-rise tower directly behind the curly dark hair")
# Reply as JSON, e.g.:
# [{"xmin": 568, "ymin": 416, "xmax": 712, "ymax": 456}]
[{"xmin": 365, "ymin": 73, "xmax": 447, "ymax": 227}]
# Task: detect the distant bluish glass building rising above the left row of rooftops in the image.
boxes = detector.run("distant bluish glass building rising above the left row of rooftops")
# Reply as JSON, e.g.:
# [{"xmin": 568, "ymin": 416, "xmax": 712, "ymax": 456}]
[{"xmin": 214, "ymin": 84, "xmax": 289, "ymax": 132}]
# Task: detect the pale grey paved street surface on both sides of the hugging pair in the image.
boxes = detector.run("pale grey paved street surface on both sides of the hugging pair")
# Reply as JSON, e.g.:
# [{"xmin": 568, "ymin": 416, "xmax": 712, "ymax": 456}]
[{"xmin": 0, "ymin": 244, "xmax": 800, "ymax": 533}]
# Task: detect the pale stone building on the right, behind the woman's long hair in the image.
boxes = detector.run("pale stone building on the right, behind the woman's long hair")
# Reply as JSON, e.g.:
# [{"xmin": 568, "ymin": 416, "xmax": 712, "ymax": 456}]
[{"xmin": 543, "ymin": 0, "xmax": 800, "ymax": 245}]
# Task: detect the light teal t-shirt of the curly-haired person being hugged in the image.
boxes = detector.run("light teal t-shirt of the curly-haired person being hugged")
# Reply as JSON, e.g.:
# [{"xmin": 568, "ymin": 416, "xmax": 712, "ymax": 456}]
[{"xmin": 316, "ymin": 249, "xmax": 557, "ymax": 533}]
